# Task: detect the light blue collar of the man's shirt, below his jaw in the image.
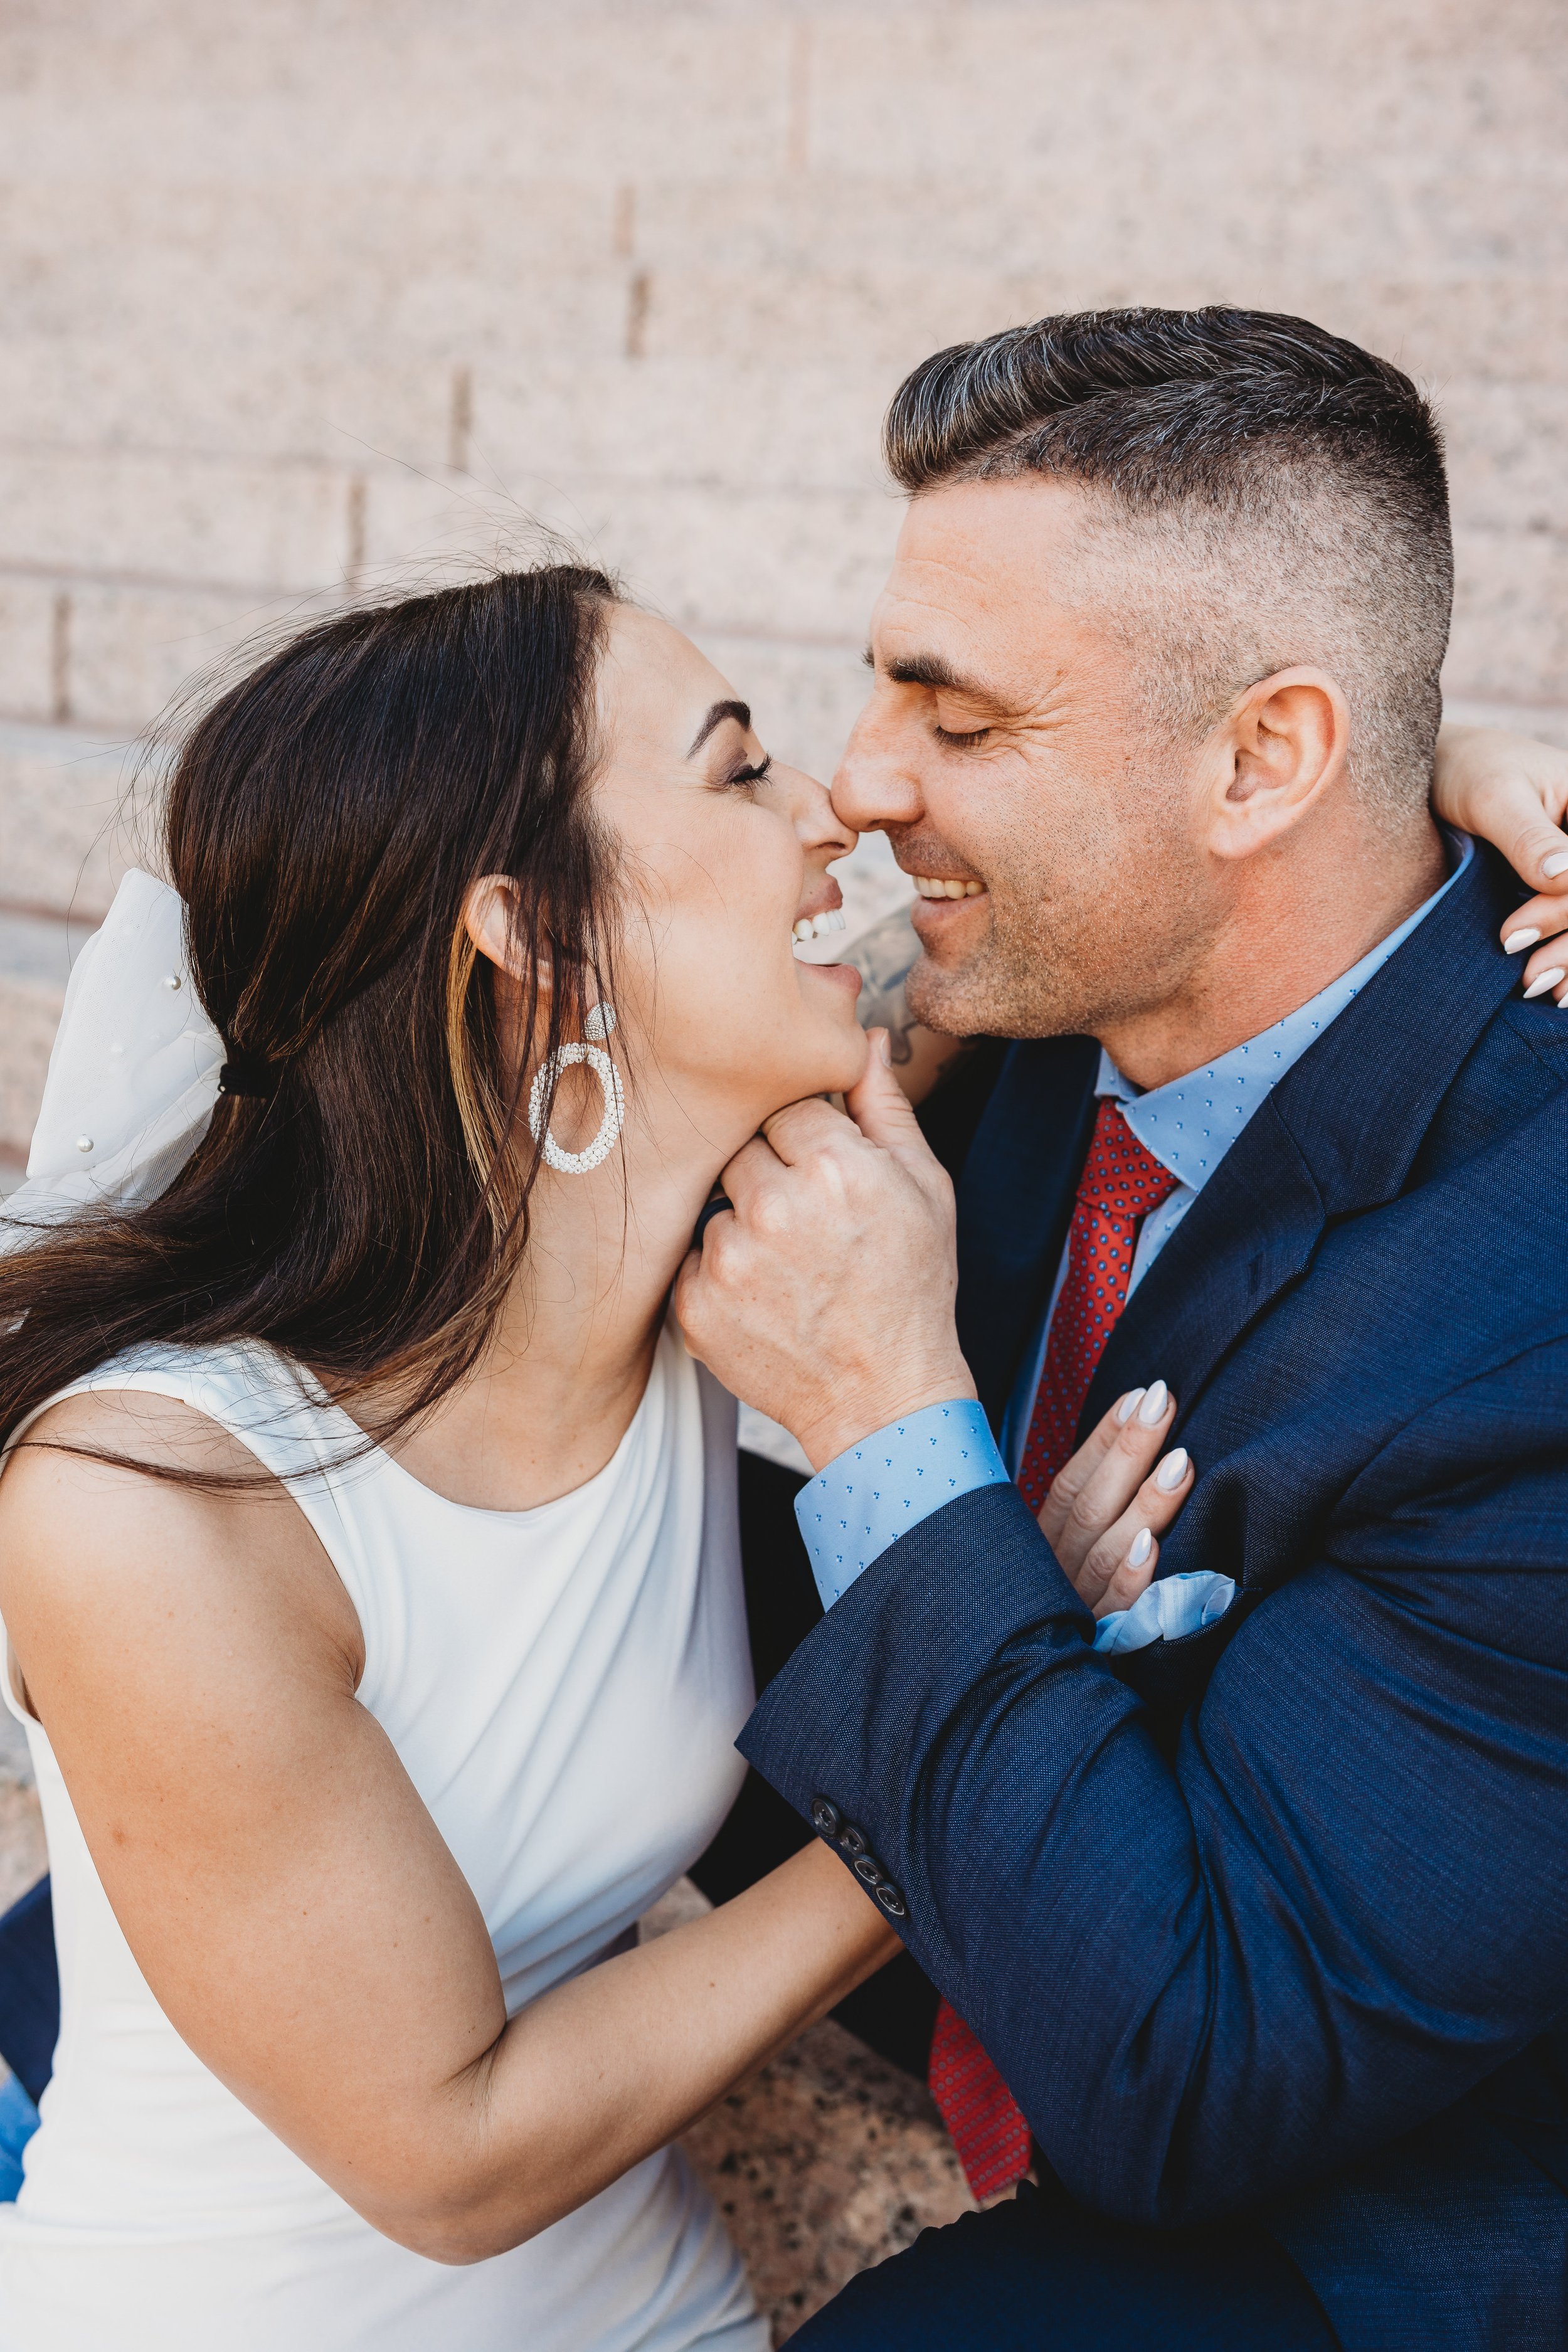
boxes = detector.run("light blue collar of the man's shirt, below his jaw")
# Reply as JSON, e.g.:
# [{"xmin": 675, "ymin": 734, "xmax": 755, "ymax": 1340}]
[{"xmin": 1096, "ymin": 825, "xmax": 1476, "ymax": 1192}]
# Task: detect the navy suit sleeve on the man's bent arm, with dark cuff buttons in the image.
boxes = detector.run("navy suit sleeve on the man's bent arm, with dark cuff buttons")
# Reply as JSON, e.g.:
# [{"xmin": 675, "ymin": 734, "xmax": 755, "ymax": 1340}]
[{"xmin": 741, "ymin": 1341, "xmax": 1568, "ymax": 2223}]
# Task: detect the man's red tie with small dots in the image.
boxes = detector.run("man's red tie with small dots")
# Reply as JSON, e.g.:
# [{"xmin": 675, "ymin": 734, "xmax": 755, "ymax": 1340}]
[{"xmin": 929, "ymin": 1098, "xmax": 1180, "ymax": 2197}]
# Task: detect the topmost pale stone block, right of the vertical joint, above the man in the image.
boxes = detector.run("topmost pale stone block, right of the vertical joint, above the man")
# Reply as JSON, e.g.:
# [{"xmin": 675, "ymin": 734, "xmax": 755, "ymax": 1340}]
[{"xmin": 804, "ymin": 0, "xmax": 1565, "ymax": 186}]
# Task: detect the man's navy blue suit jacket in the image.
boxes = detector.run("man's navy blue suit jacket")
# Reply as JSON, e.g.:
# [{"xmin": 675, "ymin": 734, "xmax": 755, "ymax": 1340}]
[{"xmin": 741, "ymin": 852, "xmax": 1568, "ymax": 2352}]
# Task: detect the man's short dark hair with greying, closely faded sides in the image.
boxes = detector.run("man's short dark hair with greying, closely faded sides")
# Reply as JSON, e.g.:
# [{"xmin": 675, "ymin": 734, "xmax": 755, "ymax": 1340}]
[{"xmin": 884, "ymin": 308, "xmax": 1453, "ymax": 830}]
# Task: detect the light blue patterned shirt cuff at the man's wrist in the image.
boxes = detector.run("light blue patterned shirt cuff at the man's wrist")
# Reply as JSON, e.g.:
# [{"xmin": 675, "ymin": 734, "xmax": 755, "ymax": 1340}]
[{"xmin": 795, "ymin": 1397, "xmax": 1009, "ymax": 1609}]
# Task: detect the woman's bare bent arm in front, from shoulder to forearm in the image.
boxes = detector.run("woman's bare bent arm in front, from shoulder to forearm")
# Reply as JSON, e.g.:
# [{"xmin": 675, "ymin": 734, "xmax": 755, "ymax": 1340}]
[{"xmin": 0, "ymin": 1397, "xmax": 898, "ymax": 2263}]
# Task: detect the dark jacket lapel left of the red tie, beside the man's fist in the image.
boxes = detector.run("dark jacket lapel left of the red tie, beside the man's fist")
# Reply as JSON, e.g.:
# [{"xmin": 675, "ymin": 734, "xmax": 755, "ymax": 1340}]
[{"xmin": 959, "ymin": 1037, "xmax": 1100, "ymax": 1430}]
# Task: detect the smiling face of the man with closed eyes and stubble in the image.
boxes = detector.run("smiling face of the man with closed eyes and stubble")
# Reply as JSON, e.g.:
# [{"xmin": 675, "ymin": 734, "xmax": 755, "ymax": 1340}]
[{"xmin": 832, "ymin": 477, "xmax": 1222, "ymax": 1037}]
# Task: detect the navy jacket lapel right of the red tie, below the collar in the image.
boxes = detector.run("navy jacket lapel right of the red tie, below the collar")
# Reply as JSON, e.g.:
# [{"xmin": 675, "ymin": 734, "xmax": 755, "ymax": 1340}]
[{"xmin": 1079, "ymin": 849, "xmax": 1518, "ymax": 1437}]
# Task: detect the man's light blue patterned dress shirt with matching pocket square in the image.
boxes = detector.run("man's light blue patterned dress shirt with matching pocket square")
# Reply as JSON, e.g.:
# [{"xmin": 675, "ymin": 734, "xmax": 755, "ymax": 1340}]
[{"xmin": 795, "ymin": 835, "xmax": 1474, "ymax": 1651}]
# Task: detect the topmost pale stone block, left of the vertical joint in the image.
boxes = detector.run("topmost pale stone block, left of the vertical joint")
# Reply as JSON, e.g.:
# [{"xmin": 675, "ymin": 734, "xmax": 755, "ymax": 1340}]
[{"xmin": 0, "ymin": 0, "xmax": 792, "ymax": 184}]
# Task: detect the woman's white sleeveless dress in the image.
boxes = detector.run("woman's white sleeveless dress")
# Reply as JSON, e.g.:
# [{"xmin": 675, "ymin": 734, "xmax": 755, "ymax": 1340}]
[{"xmin": 0, "ymin": 1332, "xmax": 769, "ymax": 2352}]
